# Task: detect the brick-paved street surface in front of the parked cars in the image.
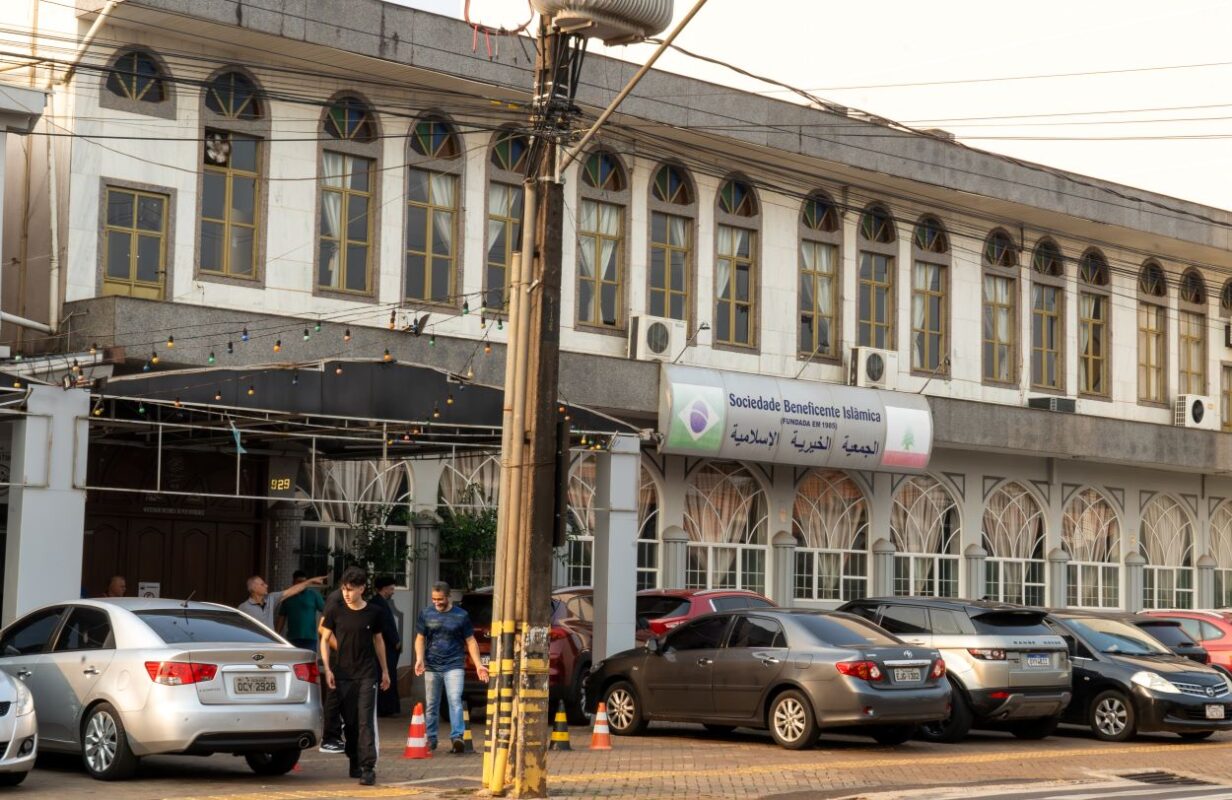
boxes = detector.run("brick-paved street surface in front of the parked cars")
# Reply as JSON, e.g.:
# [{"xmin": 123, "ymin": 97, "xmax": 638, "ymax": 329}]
[{"xmin": 26, "ymin": 720, "xmax": 1232, "ymax": 800}]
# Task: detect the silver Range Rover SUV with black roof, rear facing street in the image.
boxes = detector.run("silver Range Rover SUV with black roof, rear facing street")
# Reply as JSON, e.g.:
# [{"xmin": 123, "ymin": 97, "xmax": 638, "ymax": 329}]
[{"xmin": 839, "ymin": 597, "xmax": 1072, "ymax": 742}]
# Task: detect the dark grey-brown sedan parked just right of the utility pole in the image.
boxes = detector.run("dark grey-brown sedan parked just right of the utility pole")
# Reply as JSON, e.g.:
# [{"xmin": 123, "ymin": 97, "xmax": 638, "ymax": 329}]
[{"xmin": 586, "ymin": 609, "xmax": 950, "ymax": 749}]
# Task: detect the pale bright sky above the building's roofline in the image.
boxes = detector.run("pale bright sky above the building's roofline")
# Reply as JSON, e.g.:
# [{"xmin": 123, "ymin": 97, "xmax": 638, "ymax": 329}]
[{"xmin": 391, "ymin": 0, "xmax": 1232, "ymax": 210}]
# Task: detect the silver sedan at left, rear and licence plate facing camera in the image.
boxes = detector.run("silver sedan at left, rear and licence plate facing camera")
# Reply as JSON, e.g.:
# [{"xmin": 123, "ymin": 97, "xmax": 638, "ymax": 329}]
[{"xmin": 0, "ymin": 598, "xmax": 322, "ymax": 780}]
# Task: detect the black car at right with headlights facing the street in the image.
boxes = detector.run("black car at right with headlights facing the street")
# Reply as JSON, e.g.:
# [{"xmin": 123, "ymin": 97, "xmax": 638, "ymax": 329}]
[{"xmin": 1048, "ymin": 609, "xmax": 1232, "ymax": 742}]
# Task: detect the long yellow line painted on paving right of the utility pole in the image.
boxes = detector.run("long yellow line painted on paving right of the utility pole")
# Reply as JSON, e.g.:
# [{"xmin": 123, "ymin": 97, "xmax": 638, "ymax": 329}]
[{"xmin": 548, "ymin": 743, "xmax": 1232, "ymax": 784}]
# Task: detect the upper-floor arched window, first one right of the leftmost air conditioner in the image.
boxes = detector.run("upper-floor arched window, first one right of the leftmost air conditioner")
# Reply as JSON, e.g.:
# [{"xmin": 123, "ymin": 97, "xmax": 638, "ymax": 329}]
[{"xmin": 713, "ymin": 179, "xmax": 761, "ymax": 348}]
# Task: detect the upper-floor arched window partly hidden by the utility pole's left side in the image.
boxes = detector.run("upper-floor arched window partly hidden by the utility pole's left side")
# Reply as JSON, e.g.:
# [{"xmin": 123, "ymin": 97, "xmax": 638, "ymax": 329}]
[{"xmin": 483, "ymin": 131, "xmax": 531, "ymax": 313}]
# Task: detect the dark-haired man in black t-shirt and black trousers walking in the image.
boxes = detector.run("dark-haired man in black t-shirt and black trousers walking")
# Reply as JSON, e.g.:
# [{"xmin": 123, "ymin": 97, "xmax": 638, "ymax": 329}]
[{"xmin": 320, "ymin": 567, "xmax": 389, "ymax": 786}]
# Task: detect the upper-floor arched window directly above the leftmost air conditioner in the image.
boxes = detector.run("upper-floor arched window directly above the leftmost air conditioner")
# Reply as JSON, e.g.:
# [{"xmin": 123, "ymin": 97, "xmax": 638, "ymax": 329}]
[{"xmin": 647, "ymin": 164, "xmax": 697, "ymax": 322}]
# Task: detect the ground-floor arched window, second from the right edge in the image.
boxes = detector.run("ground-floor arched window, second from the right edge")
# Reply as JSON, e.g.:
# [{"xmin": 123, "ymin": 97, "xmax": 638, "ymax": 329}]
[{"xmin": 1138, "ymin": 494, "xmax": 1194, "ymax": 609}]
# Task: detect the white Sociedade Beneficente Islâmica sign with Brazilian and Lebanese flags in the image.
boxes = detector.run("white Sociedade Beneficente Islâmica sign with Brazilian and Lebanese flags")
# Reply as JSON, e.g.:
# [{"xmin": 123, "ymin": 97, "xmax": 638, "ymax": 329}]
[{"xmin": 659, "ymin": 365, "xmax": 933, "ymax": 472}]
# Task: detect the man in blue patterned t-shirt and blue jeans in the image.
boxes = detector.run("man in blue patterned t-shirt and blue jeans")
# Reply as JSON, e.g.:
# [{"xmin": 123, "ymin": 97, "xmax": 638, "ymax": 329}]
[{"xmin": 415, "ymin": 582, "xmax": 488, "ymax": 753}]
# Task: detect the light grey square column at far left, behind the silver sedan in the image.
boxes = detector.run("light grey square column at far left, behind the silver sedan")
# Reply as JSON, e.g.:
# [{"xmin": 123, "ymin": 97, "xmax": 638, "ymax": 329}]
[{"xmin": 2, "ymin": 386, "xmax": 90, "ymax": 625}]
